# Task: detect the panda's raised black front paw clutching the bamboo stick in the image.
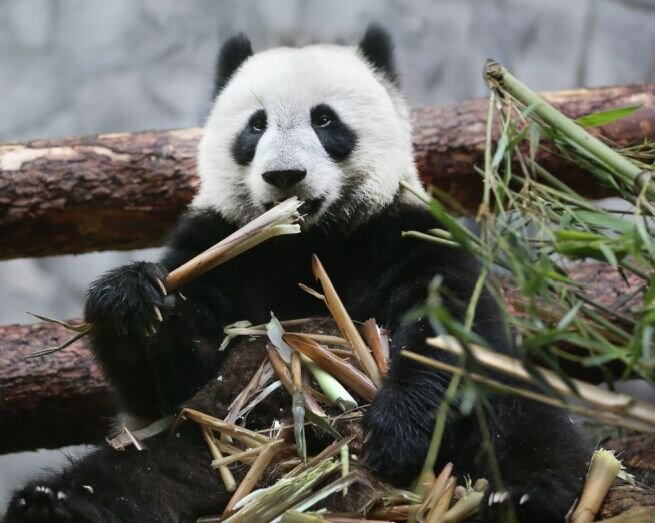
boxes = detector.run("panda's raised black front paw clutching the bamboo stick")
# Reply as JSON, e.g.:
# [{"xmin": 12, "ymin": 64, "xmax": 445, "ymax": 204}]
[{"xmin": 84, "ymin": 262, "xmax": 168, "ymax": 337}]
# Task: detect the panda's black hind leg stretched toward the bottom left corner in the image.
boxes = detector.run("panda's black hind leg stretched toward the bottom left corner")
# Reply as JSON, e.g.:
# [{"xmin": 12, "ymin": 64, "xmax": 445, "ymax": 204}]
[{"xmin": 3, "ymin": 425, "xmax": 231, "ymax": 523}]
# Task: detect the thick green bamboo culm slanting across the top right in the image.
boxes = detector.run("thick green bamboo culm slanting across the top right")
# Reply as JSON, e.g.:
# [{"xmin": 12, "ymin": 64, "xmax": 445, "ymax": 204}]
[{"xmin": 483, "ymin": 59, "xmax": 655, "ymax": 198}]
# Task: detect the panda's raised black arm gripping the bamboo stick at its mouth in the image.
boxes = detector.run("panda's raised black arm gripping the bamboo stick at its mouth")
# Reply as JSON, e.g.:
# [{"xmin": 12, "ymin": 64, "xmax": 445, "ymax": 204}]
[{"xmin": 85, "ymin": 212, "xmax": 239, "ymax": 418}]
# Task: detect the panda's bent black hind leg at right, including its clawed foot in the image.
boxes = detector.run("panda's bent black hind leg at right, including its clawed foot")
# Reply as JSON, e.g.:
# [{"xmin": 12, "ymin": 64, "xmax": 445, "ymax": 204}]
[{"xmin": 470, "ymin": 396, "xmax": 591, "ymax": 523}]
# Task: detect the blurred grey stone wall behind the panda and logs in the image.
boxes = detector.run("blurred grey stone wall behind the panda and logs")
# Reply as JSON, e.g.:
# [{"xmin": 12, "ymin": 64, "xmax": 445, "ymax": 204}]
[{"xmin": 0, "ymin": 0, "xmax": 655, "ymax": 514}]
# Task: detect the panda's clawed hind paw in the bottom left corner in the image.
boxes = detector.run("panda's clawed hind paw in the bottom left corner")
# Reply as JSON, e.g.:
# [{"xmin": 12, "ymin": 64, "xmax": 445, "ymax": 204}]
[{"xmin": 3, "ymin": 485, "xmax": 103, "ymax": 523}]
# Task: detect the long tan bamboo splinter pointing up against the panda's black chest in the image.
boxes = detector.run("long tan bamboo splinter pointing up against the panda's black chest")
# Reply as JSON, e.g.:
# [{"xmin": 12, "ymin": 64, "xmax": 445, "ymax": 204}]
[{"xmin": 312, "ymin": 255, "xmax": 382, "ymax": 388}]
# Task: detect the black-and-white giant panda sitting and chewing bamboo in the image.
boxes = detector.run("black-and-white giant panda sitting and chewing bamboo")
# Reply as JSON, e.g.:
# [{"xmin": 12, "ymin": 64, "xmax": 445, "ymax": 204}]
[{"xmin": 4, "ymin": 26, "xmax": 586, "ymax": 523}]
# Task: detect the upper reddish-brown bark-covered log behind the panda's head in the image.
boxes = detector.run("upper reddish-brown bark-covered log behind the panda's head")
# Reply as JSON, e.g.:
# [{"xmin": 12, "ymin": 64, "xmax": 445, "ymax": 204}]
[{"xmin": 0, "ymin": 83, "xmax": 655, "ymax": 259}]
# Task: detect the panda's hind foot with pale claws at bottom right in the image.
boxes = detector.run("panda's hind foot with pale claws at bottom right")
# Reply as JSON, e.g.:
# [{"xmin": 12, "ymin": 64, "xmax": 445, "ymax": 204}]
[{"xmin": 479, "ymin": 478, "xmax": 578, "ymax": 523}]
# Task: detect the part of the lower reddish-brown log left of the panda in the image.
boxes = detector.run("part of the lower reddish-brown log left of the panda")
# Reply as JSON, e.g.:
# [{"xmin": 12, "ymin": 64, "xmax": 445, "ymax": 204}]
[{"xmin": 0, "ymin": 323, "xmax": 114, "ymax": 454}]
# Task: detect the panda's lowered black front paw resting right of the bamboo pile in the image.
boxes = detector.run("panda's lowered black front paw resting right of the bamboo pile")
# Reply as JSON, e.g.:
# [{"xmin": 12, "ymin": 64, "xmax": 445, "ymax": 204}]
[{"xmin": 364, "ymin": 383, "xmax": 434, "ymax": 485}]
